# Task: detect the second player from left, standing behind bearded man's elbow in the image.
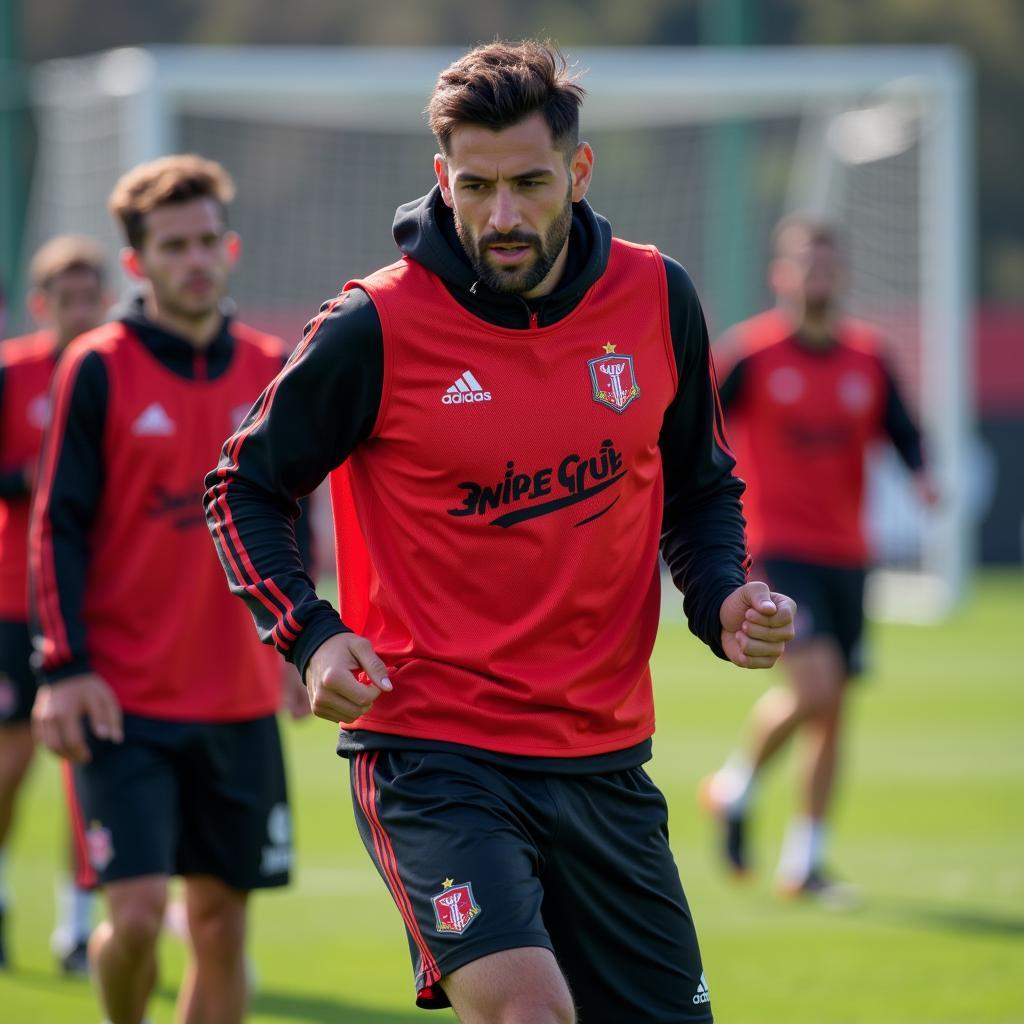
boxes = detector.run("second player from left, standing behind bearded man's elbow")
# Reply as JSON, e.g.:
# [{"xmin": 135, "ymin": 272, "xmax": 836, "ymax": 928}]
[{"xmin": 30, "ymin": 156, "xmax": 304, "ymax": 1024}]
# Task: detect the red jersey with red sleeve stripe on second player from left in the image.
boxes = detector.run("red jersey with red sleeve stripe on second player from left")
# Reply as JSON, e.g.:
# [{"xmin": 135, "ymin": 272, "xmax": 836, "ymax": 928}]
[{"xmin": 31, "ymin": 322, "xmax": 284, "ymax": 721}]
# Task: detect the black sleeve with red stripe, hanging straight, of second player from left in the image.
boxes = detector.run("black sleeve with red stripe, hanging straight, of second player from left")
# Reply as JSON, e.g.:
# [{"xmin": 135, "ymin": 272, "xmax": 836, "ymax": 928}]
[{"xmin": 29, "ymin": 352, "xmax": 108, "ymax": 683}]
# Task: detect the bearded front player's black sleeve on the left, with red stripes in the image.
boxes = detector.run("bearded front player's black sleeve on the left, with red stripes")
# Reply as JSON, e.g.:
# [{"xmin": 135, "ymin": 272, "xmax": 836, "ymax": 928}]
[{"xmin": 204, "ymin": 290, "xmax": 384, "ymax": 677}]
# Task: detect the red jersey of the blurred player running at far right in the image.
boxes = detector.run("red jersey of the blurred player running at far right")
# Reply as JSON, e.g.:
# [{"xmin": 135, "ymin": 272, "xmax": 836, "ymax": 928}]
[{"xmin": 722, "ymin": 309, "xmax": 913, "ymax": 566}]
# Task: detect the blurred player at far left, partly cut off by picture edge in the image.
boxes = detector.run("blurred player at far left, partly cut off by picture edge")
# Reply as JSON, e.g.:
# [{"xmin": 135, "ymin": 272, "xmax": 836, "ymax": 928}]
[{"xmin": 0, "ymin": 234, "xmax": 106, "ymax": 973}]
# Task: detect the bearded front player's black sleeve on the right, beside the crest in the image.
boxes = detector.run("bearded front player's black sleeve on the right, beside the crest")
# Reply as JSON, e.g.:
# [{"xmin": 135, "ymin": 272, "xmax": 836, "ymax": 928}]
[{"xmin": 658, "ymin": 257, "xmax": 746, "ymax": 658}]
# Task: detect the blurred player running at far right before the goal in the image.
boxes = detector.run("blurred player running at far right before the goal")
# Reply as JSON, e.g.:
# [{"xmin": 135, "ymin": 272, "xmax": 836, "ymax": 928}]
[{"xmin": 701, "ymin": 217, "xmax": 937, "ymax": 899}]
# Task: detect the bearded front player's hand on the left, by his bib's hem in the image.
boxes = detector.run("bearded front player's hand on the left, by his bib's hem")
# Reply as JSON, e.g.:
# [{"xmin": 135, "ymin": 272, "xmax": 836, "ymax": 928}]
[{"xmin": 306, "ymin": 633, "xmax": 392, "ymax": 725}]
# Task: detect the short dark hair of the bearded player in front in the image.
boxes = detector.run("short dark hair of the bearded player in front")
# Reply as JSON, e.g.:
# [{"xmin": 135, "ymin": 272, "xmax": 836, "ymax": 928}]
[{"xmin": 427, "ymin": 39, "xmax": 585, "ymax": 155}]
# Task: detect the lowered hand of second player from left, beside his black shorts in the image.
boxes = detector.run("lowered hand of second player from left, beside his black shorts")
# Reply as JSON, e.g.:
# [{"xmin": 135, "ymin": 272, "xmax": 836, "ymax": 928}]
[{"xmin": 32, "ymin": 672, "xmax": 124, "ymax": 763}]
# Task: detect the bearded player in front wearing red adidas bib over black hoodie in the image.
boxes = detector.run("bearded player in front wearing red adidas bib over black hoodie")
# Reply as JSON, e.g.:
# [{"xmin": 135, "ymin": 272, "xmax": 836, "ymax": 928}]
[{"xmin": 206, "ymin": 42, "xmax": 794, "ymax": 1024}]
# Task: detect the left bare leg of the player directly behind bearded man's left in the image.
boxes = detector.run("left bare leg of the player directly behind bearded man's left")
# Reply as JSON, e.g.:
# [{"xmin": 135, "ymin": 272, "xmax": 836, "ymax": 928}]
[{"xmin": 89, "ymin": 874, "xmax": 167, "ymax": 1024}]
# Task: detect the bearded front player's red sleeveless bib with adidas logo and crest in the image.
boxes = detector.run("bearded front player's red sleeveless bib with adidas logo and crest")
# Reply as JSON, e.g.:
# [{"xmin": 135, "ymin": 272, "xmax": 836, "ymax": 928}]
[{"xmin": 332, "ymin": 240, "xmax": 677, "ymax": 757}]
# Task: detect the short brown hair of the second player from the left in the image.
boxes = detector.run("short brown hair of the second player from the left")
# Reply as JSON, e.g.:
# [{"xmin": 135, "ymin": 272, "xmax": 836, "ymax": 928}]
[{"xmin": 108, "ymin": 154, "xmax": 234, "ymax": 249}]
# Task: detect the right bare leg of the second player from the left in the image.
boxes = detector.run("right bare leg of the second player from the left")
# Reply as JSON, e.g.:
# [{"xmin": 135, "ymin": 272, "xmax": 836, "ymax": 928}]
[{"xmin": 177, "ymin": 876, "xmax": 248, "ymax": 1024}]
